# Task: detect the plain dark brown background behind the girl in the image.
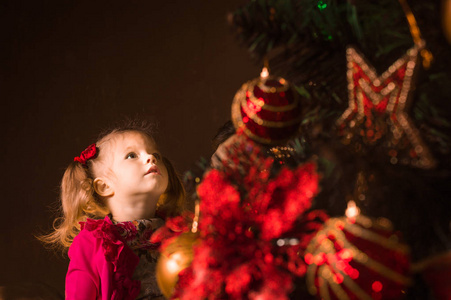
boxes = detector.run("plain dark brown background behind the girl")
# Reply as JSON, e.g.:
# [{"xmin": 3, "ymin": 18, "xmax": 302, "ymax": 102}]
[{"xmin": 0, "ymin": 0, "xmax": 260, "ymax": 292}]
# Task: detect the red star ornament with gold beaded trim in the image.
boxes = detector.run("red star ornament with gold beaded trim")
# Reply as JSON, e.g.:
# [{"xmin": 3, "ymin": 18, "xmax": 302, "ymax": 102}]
[{"xmin": 337, "ymin": 46, "xmax": 435, "ymax": 168}]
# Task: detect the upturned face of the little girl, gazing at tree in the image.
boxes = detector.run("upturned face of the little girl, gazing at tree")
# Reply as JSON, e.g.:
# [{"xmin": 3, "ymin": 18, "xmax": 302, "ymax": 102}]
[{"xmin": 102, "ymin": 131, "xmax": 168, "ymax": 201}]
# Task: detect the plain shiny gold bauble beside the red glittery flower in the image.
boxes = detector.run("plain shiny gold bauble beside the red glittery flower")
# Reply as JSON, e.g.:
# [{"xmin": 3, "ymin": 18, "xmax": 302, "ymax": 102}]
[{"xmin": 156, "ymin": 232, "xmax": 198, "ymax": 299}]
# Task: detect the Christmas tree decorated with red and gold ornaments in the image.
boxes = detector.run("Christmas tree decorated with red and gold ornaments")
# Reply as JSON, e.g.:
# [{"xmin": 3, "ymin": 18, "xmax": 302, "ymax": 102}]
[{"xmin": 154, "ymin": 0, "xmax": 451, "ymax": 299}]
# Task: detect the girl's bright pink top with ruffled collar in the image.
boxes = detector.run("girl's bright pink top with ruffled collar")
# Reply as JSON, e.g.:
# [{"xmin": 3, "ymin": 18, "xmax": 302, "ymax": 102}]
[{"xmin": 66, "ymin": 216, "xmax": 161, "ymax": 300}]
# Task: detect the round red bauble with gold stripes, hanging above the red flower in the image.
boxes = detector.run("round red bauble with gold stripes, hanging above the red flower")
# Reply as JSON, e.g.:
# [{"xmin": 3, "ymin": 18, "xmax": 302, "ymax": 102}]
[{"xmin": 232, "ymin": 68, "xmax": 301, "ymax": 145}]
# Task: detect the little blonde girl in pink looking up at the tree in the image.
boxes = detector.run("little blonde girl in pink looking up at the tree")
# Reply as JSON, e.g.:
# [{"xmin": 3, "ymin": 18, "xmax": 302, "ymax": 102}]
[{"xmin": 41, "ymin": 122, "xmax": 185, "ymax": 300}]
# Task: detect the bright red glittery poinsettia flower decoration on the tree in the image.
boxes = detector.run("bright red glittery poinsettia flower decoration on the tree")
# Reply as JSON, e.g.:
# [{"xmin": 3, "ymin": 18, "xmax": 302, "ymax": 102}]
[{"xmin": 163, "ymin": 133, "xmax": 326, "ymax": 299}]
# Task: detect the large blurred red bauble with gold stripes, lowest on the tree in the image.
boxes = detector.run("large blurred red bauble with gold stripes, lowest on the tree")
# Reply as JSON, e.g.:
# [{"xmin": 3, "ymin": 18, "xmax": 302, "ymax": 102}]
[{"xmin": 304, "ymin": 211, "xmax": 411, "ymax": 299}]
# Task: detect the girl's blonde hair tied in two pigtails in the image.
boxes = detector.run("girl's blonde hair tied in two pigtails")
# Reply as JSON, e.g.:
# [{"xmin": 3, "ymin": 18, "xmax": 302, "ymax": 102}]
[{"xmin": 37, "ymin": 126, "xmax": 185, "ymax": 250}]
